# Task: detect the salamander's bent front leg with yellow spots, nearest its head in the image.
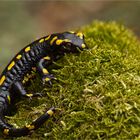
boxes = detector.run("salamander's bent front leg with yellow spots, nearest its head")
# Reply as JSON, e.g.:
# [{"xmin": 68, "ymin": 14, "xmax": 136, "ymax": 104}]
[{"xmin": 37, "ymin": 56, "xmax": 56, "ymax": 85}]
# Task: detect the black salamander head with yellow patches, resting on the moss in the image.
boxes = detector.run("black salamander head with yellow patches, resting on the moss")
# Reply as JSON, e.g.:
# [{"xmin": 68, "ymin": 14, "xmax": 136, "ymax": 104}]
[{"xmin": 55, "ymin": 31, "xmax": 87, "ymax": 53}]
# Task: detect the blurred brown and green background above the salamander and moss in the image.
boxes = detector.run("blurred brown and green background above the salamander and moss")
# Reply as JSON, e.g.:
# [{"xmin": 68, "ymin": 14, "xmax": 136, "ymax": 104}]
[{"xmin": 0, "ymin": 0, "xmax": 140, "ymax": 72}]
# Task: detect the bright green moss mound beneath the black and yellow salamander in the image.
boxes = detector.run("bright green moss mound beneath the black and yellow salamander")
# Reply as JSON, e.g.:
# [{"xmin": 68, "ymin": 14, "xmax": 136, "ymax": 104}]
[{"xmin": 7, "ymin": 22, "xmax": 140, "ymax": 140}]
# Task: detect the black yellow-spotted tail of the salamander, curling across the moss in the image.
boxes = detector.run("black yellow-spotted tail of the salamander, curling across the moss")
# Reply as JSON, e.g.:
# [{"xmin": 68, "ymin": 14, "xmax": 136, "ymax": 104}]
[{"xmin": 0, "ymin": 107, "xmax": 56, "ymax": 137}]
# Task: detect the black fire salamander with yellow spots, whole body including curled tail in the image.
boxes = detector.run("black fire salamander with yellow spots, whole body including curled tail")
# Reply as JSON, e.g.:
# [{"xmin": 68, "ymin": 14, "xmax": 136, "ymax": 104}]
[{"xmin": 0, "ymin": 31, "xmax": 87, "ymax": 137}]
